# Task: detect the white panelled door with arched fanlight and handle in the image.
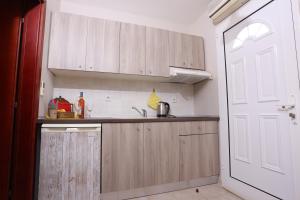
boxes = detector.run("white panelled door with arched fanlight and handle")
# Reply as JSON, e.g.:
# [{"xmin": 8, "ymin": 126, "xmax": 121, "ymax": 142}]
[{"xmin": 224, "ymin": 1, "xmax": 299, "ymax": 200}]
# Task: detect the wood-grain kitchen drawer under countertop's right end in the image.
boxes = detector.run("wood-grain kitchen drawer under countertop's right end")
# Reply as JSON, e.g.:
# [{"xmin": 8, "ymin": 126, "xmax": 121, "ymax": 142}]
[{"xmin": 179, "ymin": 121, "xmax": 218, "ymax": 135}]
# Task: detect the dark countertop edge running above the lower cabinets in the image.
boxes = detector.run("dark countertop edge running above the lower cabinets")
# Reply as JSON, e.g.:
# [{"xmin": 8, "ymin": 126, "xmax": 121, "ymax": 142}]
[{"xmin": 37, "ymin": 116, "xmax": 220, "ymax": 124}]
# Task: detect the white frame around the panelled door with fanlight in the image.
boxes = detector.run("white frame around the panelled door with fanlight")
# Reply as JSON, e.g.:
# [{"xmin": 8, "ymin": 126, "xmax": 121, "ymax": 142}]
[{"xmin": 216, "ymin": 0, "xmax": 300, "ymax": 200}]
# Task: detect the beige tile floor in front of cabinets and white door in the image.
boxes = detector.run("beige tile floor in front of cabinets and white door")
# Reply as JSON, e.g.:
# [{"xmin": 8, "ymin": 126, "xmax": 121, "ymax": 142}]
[{"xmin": 133, "ymin": 184, "xmax": 242, "ymax": 200}]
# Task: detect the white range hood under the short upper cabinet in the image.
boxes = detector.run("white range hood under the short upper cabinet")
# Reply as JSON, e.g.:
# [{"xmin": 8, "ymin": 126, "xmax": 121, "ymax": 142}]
[{"xmin": 168, "ymin": 67, "xmax": 212, "ymax": 84}]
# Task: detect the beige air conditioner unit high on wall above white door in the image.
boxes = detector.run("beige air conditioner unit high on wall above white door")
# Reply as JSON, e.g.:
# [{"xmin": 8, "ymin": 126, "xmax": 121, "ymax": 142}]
[{"xmin": 209, "ymin": 0, "xmax": 249, "ymax": 24}]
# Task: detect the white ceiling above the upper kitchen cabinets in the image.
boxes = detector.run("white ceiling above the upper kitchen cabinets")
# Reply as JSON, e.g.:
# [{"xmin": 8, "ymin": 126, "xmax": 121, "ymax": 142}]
[{"xmin": 62, "ymin": 0, "xmax": 212, "ymax": 23}]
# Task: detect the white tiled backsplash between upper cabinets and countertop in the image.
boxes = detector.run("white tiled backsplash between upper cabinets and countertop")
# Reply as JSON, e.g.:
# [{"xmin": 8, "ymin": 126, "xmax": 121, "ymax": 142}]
[{"xmin": 53, "ymin": 77, "xmax": 194, "ymax": 117}]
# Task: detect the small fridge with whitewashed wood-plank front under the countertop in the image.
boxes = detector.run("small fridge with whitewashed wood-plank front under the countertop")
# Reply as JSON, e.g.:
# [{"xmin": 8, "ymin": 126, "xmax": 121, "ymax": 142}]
[{"xmin": 35, "ymin": 124, "xmax": 101, "ymax": 199}]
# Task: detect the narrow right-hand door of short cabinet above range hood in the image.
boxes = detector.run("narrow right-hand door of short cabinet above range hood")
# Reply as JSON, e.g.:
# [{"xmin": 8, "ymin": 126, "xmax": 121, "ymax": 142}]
[{"xmin": 190, "ymin": 36, "xmax": 205, "ymax": 70}]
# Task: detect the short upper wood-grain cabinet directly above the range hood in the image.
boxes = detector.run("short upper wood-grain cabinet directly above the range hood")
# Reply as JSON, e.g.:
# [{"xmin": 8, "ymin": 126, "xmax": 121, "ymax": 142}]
[{"xmin": 169, "ymin": 32, "xmax": 205, "ymax": 70}]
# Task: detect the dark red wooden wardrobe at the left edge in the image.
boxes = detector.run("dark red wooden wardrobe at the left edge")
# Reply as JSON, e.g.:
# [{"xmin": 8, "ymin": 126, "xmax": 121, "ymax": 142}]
[{"xmin": 0, "ymin": 0, "xmax": 45, "ymax": 200}]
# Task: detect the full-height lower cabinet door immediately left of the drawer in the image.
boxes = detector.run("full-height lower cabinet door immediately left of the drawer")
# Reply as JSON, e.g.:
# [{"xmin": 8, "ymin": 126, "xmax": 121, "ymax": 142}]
[{"xmin": 144, "ymin": 123, "xmax": 179, "ymax": 186}]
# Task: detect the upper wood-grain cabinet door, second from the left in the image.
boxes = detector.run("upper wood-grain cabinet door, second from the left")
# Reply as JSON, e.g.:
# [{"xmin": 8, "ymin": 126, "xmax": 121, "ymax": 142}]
[{"xmin": 86, "ymin": 18, "xmax": 120, "ymax": 73}]
